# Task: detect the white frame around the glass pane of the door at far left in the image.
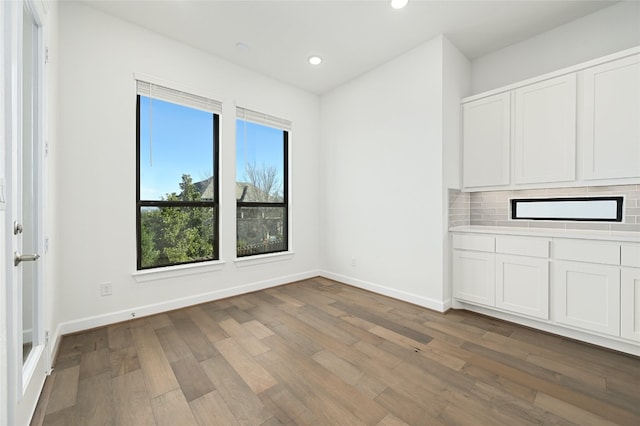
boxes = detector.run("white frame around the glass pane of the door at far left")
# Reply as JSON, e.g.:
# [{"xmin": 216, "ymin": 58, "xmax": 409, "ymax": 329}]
[{"xmin": 0, "ymin": 0, "xmax": 50, "ymax": 425}]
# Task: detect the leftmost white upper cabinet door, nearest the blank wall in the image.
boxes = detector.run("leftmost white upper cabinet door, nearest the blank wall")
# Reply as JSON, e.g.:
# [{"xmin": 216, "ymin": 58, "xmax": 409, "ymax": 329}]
[{"xmin": 462, "ymin": 93, "xmax": 511, "ymax": 188}]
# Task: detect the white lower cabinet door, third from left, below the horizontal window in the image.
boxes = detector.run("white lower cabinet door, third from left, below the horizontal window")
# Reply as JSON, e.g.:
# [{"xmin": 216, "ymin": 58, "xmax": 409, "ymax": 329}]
[{"xmin": 552, "ymin": 261, "xmax": 620, "ymax": 336}]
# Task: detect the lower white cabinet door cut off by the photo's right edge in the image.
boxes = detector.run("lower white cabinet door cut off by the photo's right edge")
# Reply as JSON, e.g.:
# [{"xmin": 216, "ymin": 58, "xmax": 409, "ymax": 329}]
[{"xmin": 620, "ymin": 269, "xmax": 640, "ymax": 342}]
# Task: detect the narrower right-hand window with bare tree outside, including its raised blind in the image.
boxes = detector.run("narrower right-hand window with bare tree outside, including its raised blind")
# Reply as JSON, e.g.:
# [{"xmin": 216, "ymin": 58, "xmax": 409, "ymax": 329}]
[{"xmin": 236, "ymin": 108, "xmax": 291, "ymax": 257}]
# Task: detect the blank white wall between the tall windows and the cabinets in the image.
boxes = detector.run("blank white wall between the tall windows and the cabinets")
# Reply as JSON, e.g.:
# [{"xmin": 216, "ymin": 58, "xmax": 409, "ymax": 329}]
[{"xmin": 321, "ymin": 37, "xmax": 468, "ymax": 310}]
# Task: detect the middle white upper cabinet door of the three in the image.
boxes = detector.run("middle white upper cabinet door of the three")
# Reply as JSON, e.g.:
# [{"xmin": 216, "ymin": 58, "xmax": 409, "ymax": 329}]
[{"xmin": 514, "ymin": 74, "xmax": 576, "ymax": 183}]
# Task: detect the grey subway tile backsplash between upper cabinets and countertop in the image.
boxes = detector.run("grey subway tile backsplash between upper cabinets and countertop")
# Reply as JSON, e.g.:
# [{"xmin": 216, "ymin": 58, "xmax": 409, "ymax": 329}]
[{"xmin": 449, "ymin": 185, "xmax": 640, "ymax": 232}]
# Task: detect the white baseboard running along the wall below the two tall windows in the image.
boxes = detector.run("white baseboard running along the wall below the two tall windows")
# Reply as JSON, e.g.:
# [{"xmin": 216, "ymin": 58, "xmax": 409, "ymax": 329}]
[{"xmin": 51, "ymin": 270, "xmax": 321, "ymax": 360}]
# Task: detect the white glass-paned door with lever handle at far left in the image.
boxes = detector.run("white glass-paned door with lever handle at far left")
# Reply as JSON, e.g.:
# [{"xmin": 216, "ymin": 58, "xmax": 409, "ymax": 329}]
[{"xmin": 0, "ymin": 1, "xmax": 48, "ymax": 425}]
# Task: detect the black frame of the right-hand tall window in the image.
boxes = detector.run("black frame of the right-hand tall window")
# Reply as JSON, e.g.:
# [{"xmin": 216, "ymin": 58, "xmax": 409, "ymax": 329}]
[{"xmin": 236, "ymin": 125, "xmax": 289, "ymax": 258}]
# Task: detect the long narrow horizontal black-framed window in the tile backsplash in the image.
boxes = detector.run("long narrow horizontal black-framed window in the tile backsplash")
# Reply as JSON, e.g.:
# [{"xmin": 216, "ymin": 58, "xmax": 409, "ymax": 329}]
[{"xmin": 510, "ymin": 196, "xmax": 624, "ymax": 222}]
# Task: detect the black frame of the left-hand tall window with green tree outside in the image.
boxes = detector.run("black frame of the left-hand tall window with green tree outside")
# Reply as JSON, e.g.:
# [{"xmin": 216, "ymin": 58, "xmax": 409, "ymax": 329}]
[{"xmin": 136, "ymin": 94, "xmax": 220, "ymax": 271}]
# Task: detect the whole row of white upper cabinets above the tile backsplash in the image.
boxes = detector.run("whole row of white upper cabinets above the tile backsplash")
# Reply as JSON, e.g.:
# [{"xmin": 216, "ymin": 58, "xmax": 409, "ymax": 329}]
[{"xmin": 462, "ymin": 47, "xmax": 640, "ymax": 191}]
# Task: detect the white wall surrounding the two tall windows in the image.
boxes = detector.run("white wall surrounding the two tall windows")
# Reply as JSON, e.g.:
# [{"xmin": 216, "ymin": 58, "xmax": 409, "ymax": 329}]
[{"xmin": 55, "ymin": 2, "xmax": 320, "ymax": 333}]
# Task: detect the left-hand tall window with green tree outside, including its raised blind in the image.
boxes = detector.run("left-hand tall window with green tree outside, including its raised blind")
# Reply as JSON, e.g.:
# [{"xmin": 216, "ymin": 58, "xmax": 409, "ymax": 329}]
[{"xmin": 135, "ymin": 81, "xmax": 221, "ymax": 270}]
